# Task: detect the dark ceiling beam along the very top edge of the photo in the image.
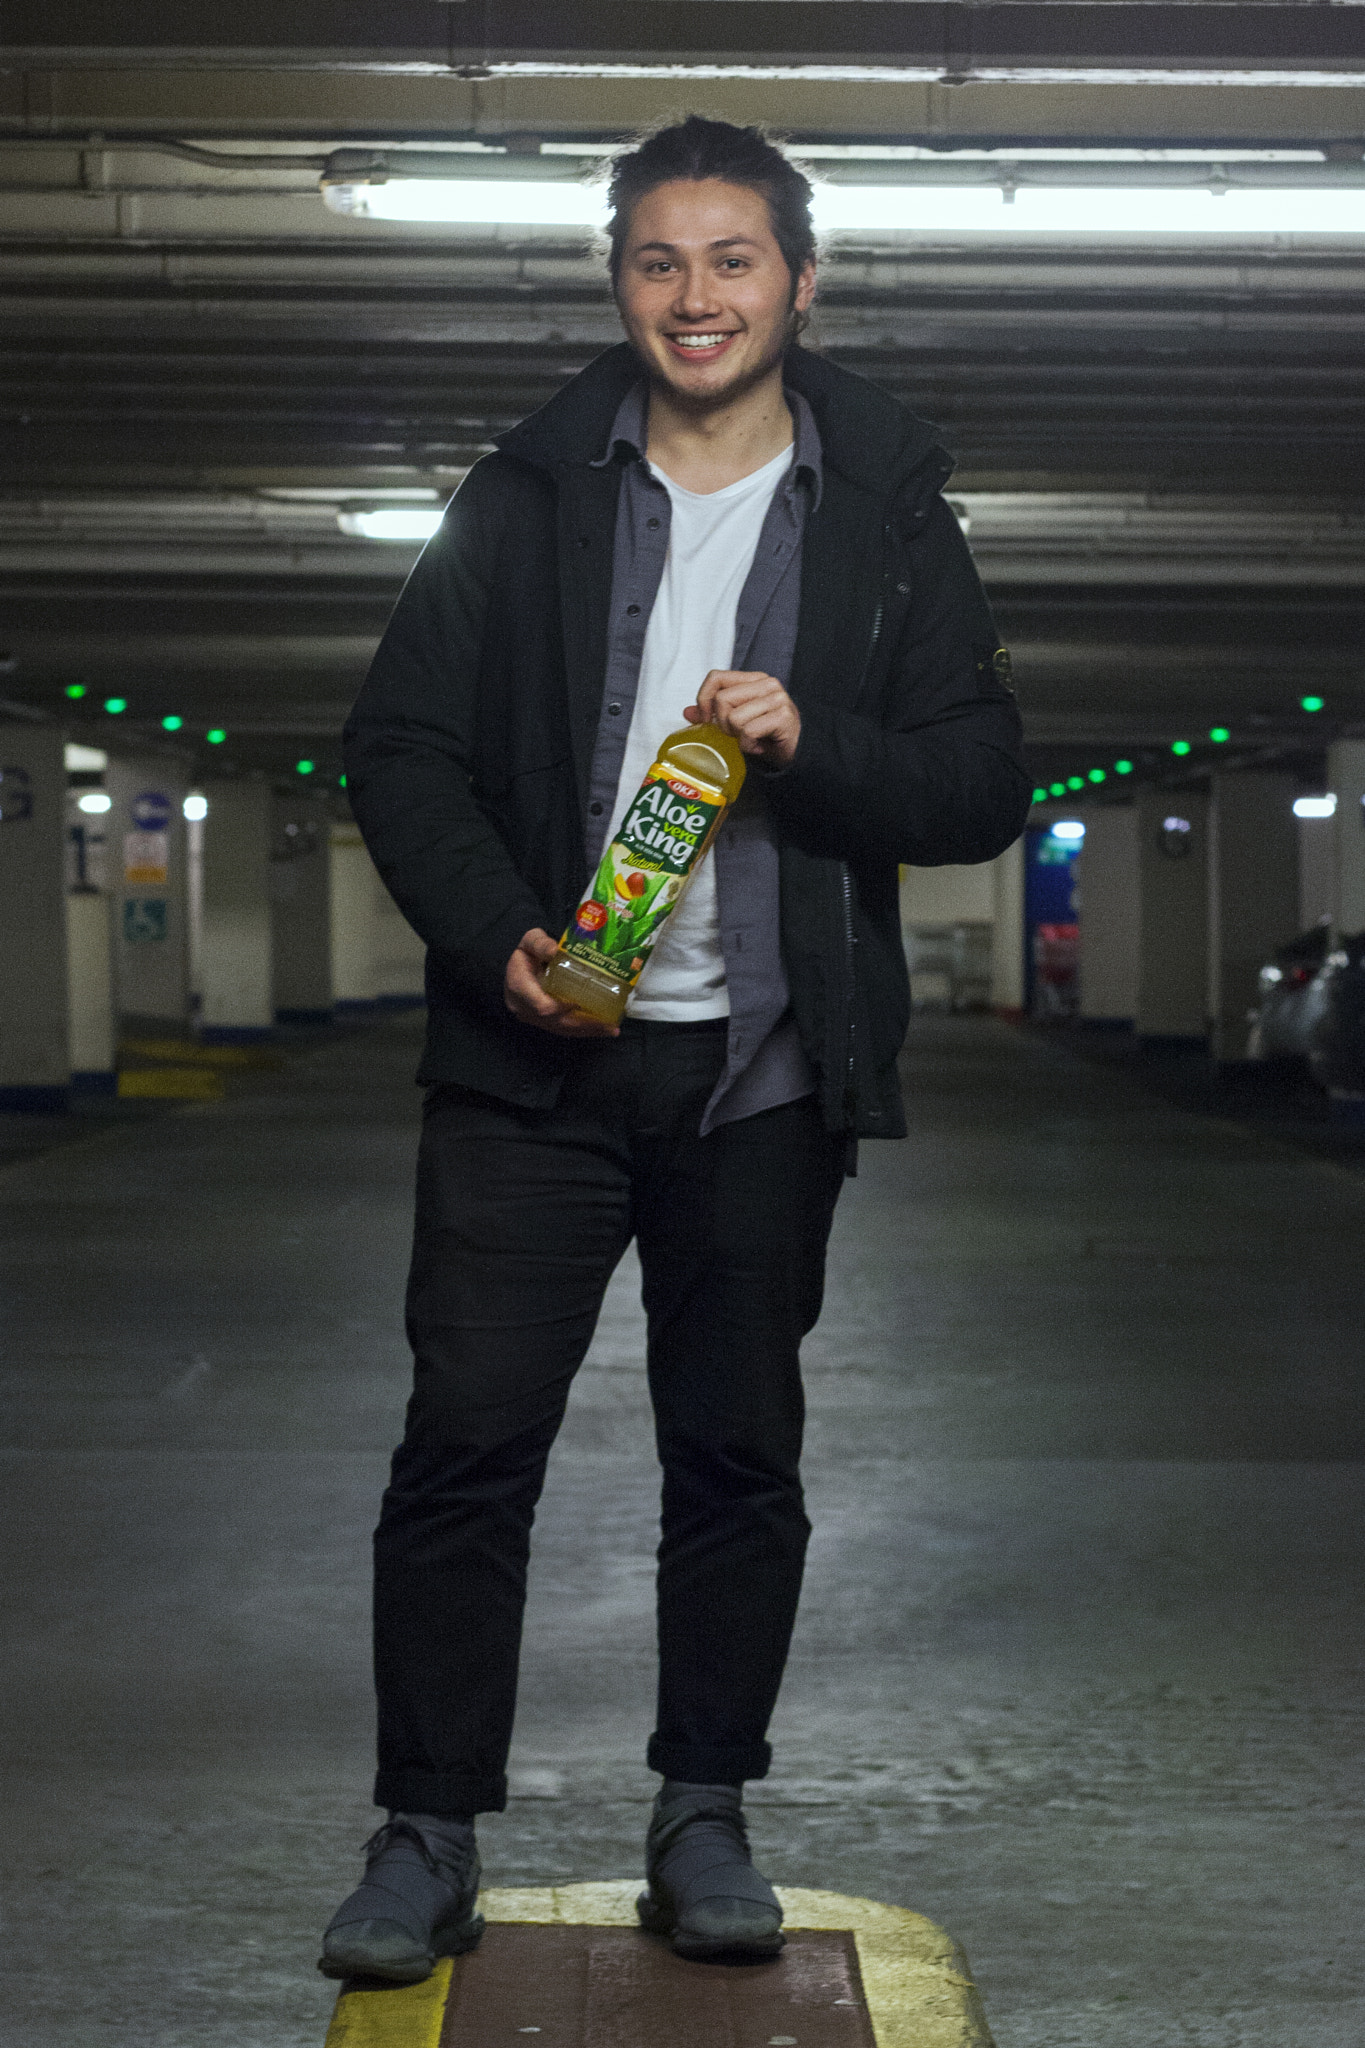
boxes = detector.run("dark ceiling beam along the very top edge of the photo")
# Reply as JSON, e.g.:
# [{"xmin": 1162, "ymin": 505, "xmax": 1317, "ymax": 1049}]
[{"xmin": 0, "ymin": 0, "xmax": 1365, "ymax": 86}]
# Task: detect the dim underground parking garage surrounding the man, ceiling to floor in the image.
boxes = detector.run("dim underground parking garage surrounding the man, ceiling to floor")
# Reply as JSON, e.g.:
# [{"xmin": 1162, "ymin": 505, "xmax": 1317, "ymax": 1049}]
[{"xmin": 0, "ymin": 12, "xmax": 1365, "ymax": 2048}]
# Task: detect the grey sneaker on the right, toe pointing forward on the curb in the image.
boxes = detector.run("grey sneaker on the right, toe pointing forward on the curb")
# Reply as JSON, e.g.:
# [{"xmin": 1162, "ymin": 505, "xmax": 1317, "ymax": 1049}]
[{"xmin": 634, "ymin": 1786, "xmax": 784, "ymax": 1962}]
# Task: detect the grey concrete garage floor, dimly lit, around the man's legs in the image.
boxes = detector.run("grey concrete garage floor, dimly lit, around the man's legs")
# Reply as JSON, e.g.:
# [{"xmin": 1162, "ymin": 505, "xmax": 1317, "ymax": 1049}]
[{"xmin": 0, "ymin": 1020, "xmax": 1365, "ymax": 2048}]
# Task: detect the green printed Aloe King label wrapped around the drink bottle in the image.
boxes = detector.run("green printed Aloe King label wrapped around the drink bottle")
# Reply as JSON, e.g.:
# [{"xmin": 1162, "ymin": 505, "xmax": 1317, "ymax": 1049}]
[{"xmin": 563, "ymin": 762, "xmax": 724, "ymax": 983}]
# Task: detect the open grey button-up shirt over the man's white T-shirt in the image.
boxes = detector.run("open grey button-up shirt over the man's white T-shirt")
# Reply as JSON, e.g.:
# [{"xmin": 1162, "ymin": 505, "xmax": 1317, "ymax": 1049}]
[{"xmin": 585, "ymin": 383, "xmax": 821, "ymax": 1133}]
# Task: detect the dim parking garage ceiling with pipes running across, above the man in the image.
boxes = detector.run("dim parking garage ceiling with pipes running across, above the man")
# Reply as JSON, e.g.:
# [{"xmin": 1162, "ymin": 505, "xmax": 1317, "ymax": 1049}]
[{"xmin": 0, "ymin": 0, "xmax": 1365, "ymax": 790}]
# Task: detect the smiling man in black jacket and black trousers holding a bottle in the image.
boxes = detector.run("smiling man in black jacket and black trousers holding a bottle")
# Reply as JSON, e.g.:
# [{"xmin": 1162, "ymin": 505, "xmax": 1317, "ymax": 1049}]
[{"xmin": 321, "ymin": 117, "xmax": 1029, "ymax": 1982}]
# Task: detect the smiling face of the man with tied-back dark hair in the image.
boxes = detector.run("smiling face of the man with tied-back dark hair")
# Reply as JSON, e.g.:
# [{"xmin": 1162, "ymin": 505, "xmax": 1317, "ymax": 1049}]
[{"xmin": 616, "ymin": 178, "xmax": 814, "ymax": 412}]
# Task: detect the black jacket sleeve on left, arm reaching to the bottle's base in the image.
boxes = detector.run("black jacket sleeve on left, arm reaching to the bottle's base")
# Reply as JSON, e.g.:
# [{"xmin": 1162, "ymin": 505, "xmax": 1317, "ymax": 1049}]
[{"xmin": 344, "ymin": 457, "xmax": 544, "ymax": 1012}]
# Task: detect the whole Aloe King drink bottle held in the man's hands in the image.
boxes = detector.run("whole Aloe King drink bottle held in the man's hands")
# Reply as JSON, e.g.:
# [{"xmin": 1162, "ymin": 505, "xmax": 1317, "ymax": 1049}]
[{"xmin": 540, "ymin": 725, "xmax": 745, "ymax": 1024}]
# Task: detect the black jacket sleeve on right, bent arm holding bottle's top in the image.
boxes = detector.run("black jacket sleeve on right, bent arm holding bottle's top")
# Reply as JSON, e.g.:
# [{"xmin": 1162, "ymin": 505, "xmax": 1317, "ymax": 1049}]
[{"xmin": 767, "ymin": 498, "xmax": 1031, "ymax": 866}]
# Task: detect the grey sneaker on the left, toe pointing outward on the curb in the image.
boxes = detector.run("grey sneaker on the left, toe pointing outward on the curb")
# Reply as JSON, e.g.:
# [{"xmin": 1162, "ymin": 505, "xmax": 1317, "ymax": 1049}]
[{"xmin": 317, "ymin": 1812, "xmax": 483, "ymax": 1985}]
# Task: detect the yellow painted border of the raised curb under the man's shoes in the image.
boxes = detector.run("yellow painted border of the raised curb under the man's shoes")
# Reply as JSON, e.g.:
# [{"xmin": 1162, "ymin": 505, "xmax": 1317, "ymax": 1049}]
[{"xmin": 325, "ymin": 1878, "xmax": 993, "ymax": 2048}]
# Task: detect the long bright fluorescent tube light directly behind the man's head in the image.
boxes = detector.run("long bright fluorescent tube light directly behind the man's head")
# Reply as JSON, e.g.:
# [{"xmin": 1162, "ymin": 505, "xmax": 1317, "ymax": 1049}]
[{"xmin": 323, "ymin": 176, "xmax": 1365, "ymax": 238}]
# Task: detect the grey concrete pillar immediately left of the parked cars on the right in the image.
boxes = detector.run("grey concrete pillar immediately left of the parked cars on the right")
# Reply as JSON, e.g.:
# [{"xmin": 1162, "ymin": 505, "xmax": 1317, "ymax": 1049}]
[{"xmin": 1209, "ymin": 770, "xmax": 1300, "ymax": 1059}]
